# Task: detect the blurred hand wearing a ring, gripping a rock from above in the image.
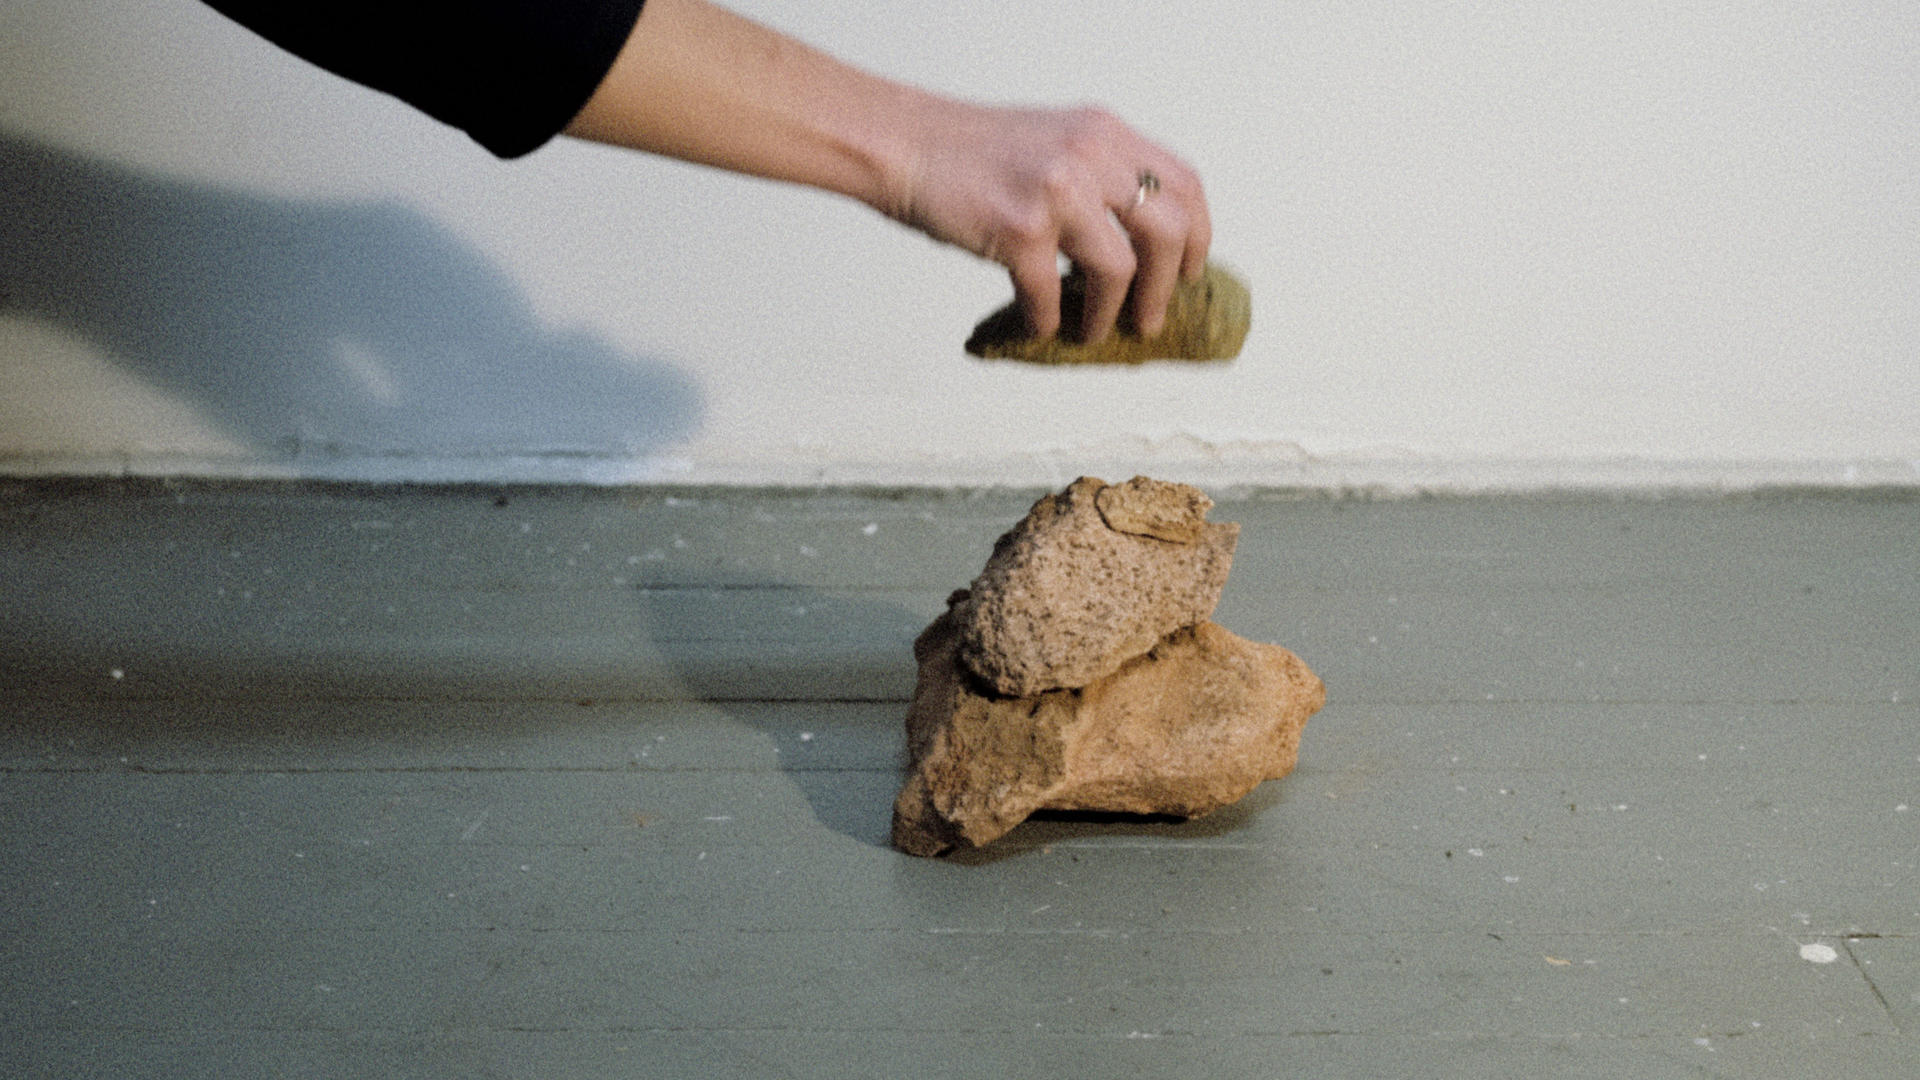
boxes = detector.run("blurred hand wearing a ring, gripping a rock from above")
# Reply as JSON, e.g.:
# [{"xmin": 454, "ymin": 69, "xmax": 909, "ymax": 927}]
[{"xmin": 881, "ymin": 100, "xmax": 1213, "ymax": 342}]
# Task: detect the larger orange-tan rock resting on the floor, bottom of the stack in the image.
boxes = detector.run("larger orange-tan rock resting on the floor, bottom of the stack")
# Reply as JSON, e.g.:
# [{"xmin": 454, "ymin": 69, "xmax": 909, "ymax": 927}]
[{"xmin": 893, "ymin": 607, "xmax": 1327, "ymax": 855}]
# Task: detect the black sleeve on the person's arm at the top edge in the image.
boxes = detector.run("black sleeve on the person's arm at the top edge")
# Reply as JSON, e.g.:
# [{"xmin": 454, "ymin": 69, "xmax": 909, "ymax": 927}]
[{"xmin": 205, "ymin": 0, "xmax": 645, "ymax": 158}]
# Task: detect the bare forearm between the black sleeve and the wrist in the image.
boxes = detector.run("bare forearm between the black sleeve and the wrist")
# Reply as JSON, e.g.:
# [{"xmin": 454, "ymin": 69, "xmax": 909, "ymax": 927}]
[{"xmin": 566, "ymin": 0, "xmax": 929, "ymax": 217}]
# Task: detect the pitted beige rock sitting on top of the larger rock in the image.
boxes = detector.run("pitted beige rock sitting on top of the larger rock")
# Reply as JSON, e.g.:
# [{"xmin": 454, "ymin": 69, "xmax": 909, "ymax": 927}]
[{"xmin": 954, "ymin": 477, "xmax": 1240, "ymax": 698}]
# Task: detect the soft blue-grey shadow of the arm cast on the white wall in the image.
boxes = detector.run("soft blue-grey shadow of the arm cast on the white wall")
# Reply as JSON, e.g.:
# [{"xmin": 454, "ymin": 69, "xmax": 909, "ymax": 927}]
[{"xmin": 0, "ymin": 133, "xmax": 701, "ymax": 457}]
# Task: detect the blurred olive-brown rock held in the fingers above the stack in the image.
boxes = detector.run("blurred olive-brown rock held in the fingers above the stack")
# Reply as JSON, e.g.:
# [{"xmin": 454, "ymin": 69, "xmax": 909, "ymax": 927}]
[{"xmin": 966, "ymin": 263, "xmax": 1254, "ymax": 363}]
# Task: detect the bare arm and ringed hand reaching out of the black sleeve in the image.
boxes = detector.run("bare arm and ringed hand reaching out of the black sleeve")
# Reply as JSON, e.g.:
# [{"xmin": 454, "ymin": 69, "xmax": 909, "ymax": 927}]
[{"xmin": 566, "ymin": 0, "xmax": 1212, "ymax": 340}]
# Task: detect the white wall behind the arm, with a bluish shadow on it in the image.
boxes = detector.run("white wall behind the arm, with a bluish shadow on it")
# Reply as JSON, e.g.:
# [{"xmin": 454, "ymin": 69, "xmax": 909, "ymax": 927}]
[{"xmin": 0, "ymin": 0, "xmax": 1920, "ymax": 486}]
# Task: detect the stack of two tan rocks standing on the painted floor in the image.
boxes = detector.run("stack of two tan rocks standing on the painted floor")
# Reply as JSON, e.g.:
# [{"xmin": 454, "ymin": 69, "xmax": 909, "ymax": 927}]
[{"xmin": 893, "ymin": 477, "xmax": 1327, "ymax": 855}]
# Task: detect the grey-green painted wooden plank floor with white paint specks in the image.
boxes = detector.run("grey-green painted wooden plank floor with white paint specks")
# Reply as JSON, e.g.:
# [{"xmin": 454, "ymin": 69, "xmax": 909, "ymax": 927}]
[{"xmin": 0, "ymin": 482, "xmax": 1920, "ymax": 1080}]
